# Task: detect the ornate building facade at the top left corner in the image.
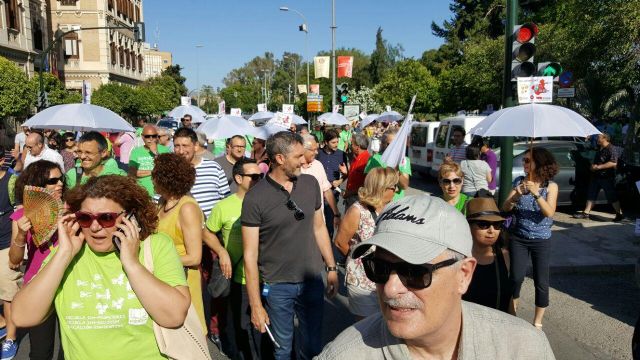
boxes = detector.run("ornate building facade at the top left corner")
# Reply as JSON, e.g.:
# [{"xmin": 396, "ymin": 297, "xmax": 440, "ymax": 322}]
[{"xmin": 0, "ymin": 0, "xmax": 49, "ymax": 77}]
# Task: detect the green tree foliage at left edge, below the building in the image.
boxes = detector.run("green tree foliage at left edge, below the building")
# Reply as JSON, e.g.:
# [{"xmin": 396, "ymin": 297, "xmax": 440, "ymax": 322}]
[{"xmin": 0, "ymin": 57, "xmax": 30, "ymax": 118}]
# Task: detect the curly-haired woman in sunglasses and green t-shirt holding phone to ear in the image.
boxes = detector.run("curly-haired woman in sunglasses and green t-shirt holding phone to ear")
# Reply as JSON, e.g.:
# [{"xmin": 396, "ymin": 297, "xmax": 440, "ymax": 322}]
[{"xmin": 12, "ymin": 175, "xmax": 191, "ymax": 359}]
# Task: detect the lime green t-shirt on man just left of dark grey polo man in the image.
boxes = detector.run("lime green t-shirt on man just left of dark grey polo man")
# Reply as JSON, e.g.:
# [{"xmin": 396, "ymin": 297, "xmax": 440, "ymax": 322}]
[{"xmin": 206, "ymin": 194, "xmax": 246, "ymax": 284}]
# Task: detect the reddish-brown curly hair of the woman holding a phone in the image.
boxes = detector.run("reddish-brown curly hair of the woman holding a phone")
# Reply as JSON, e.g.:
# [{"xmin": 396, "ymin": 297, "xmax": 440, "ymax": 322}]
[{"xmin": 65, "ymin": 175, "xmax": 158, "ymax": 239}]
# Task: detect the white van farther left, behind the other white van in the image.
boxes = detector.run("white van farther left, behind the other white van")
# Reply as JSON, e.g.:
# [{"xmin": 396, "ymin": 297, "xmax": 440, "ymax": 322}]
[{"xmin": 409, "ymin": 121, "xmax": 440, "ymax": 175}]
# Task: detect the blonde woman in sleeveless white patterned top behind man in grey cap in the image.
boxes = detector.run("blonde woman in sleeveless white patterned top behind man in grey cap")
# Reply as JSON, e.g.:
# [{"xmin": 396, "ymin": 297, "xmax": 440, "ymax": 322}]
[{"xmin": 335, "ymin": 168, "xmax": 398, "ymax": 320}]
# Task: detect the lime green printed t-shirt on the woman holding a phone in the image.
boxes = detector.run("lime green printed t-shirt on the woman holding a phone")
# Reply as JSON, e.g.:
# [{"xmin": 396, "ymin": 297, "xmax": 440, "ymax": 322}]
[{"xmin": 43, "ymin": 233, "xmax": 187, "ymax": 359}]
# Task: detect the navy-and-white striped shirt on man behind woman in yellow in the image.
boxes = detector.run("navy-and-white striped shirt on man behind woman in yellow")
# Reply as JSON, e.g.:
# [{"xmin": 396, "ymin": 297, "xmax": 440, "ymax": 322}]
[{"xmin": 191, "ymin": 159, "xmax": 231, "ymax": 219}]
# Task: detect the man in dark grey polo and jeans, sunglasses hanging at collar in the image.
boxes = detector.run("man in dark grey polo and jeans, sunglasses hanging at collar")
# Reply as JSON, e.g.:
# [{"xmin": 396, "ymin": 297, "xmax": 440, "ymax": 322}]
[{"xmin": 241, "ymin": 131, "xmax": 338, "ymax": 359}]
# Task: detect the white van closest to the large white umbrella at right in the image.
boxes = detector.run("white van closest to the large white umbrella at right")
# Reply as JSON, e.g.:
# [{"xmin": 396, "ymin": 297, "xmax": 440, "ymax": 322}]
[{"xmin": 429, "ymin": 112, "xmax": 486, "ymax": 177}]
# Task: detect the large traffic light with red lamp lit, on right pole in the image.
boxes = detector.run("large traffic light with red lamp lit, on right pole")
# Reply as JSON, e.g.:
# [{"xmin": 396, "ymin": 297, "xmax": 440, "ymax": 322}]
[{"xmin": 511, "ymin": 23, "xmax": 538, "ymax": 81}]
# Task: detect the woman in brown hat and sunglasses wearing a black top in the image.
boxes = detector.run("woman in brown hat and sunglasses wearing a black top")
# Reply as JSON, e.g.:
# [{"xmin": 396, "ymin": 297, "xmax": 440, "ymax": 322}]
[{"xmin": 462, "ymin": 197, "xmax": 513, "ymax": 312}]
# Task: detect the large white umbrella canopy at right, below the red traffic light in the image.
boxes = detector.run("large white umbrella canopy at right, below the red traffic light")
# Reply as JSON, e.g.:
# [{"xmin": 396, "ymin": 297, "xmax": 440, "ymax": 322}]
[{"xmin": 470, "ymin": 103, "xmax": 600, "ymax": 138}]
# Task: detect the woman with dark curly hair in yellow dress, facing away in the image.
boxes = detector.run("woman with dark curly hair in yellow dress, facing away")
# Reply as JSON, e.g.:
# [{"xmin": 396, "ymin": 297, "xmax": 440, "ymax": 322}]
[{"xmin": 151, "ymin": 153, "xmax": 207, "ymax": 334}]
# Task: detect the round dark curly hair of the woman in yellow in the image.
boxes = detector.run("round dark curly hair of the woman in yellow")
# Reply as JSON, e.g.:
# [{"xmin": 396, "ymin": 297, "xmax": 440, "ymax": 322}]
[{"xmin": 151, "ymin": 153, "xmax": 196, "ymax": 198}]
